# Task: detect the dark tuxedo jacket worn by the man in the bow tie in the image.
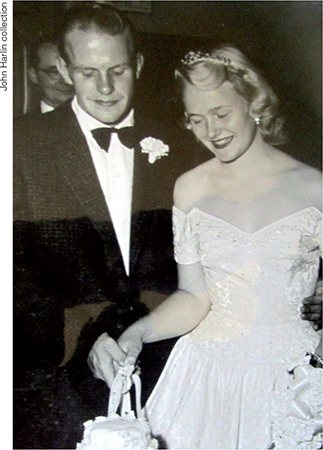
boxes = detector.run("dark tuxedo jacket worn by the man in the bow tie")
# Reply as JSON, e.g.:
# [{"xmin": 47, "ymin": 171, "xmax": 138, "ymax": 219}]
[{"xmin": 14, "ymin": 102, "xmax": 209, "ymax": 373}]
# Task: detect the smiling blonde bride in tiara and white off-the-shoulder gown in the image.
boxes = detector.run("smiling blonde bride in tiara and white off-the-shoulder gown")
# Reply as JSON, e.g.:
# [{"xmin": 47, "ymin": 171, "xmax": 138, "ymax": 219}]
[{"xmin": 90, "ymin": 46, "xmax": 322, "ymax": 449}]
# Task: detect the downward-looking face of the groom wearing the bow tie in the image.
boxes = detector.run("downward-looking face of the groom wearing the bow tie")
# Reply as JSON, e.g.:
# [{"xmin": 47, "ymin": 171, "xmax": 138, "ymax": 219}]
[{"xmin": 66, "ymin": 29, "xmax": 142, "ymax": 124}]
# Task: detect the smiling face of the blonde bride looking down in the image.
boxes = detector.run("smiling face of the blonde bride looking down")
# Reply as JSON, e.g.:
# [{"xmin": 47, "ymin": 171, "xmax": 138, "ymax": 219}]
[{"xmin": 183, "ymin": 81, "xmax": 257, "ymax": 163}]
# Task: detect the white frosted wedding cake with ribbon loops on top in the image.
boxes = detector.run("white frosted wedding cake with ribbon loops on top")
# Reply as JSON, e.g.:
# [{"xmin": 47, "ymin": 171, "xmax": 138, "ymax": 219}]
[{"xmin": 76, "ymin": 366, "xmax": 158, "ymax": 450}]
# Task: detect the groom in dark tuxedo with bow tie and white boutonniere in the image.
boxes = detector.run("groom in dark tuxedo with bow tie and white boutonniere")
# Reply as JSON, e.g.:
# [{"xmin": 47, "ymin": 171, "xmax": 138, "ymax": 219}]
[{"xmin": 14, "ymin": 2, "xmax": 206, "ymax": 448}]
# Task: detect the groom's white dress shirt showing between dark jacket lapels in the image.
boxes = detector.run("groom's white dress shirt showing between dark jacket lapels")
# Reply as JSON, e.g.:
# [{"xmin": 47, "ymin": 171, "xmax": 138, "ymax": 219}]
[{"xmin": 72, "ymin": 96, "xmax": 134, "ymax": 275}]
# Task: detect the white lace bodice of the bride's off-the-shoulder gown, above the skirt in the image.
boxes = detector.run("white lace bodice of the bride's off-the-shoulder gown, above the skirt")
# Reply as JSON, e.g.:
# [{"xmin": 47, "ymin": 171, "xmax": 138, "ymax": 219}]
[{"xmin": 173, "ymin": 207, "xmax": 321, "ymax": 366}]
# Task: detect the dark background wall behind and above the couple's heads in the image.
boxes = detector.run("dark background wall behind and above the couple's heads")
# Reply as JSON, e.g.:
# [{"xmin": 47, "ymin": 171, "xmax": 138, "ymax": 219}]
[{"xmin": 13, "ymin": 1, "xmax": 322, "ymax": 168}]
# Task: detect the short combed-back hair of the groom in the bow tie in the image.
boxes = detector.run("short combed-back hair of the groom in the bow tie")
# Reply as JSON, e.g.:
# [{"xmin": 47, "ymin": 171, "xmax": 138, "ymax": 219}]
[{"xmin": 57, "ymin": 1, "xmax": 136, "ymax": 62}]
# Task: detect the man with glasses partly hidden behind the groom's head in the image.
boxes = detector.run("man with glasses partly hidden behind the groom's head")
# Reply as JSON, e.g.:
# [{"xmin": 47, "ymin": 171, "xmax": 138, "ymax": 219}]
[{"xmin": 28, "ymin": 38, "xmax": 74, "ymax": 113}]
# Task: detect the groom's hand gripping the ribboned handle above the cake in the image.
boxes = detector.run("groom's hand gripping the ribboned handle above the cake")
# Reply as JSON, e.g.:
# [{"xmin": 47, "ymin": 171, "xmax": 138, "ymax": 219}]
[{"xmin": 87, "ymin": 333, "xmax": 127, "ymax": 387}]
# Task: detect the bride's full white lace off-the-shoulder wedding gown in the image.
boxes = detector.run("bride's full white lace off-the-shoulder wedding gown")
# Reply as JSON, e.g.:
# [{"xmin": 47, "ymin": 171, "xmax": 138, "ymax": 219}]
[{"xmin": 146, "ymin": 164, "xmax": 322, "ymax": 449}]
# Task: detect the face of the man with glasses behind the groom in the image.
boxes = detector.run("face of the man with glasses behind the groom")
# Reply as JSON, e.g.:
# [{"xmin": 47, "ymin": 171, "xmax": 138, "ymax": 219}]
[{"xmin": 29, "ymin": 43, "xmax": 74, "ymax": 108}]
